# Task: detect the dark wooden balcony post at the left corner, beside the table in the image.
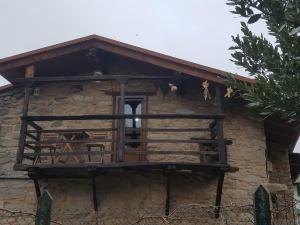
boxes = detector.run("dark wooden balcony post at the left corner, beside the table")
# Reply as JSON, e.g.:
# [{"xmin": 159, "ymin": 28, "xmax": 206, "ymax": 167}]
[{"xmin": 17, "ymin": 84, "xmax": 32, "ymax": 164}]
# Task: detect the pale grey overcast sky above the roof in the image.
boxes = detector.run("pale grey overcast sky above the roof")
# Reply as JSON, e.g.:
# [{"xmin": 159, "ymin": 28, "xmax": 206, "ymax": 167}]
[{"xmin": 0, "ymin": 0, "xmax": 300, "ymax": 151}]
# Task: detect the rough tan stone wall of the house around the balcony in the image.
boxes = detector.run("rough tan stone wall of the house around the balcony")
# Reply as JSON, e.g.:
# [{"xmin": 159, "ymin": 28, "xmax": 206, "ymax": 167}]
[{"xmin": 0, "ymin": 82, "xmax": 289, "ymax": 225}]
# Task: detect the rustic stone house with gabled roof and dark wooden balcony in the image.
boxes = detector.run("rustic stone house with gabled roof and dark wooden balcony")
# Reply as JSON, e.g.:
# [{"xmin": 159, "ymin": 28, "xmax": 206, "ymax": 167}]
[{"xmin": 0, "ymin": 35, "xmax": 299, "ymax": 225}]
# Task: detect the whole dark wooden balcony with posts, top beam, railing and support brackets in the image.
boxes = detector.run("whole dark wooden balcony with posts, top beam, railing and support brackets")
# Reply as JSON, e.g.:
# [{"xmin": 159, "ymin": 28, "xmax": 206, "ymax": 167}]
[{"xmin": 11, "ymin": 74, "xmax": 232, "ymax": 213}]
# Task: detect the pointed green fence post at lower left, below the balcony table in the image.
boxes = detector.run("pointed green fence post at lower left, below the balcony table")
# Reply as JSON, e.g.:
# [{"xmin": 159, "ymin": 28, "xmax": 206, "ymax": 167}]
[{"xmin": 35, "ymin": 190, "xmax": 53, "ymax": 225}]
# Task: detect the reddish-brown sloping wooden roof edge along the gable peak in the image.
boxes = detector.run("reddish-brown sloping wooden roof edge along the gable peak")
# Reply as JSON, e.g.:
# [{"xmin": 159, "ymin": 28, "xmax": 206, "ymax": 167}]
[{"xmin": 0, "ymin": 35, "xmax": 254, "ymax": 83}]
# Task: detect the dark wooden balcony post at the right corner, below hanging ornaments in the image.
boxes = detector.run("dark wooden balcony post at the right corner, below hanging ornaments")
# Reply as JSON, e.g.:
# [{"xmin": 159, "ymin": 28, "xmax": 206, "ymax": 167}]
[{"xmin": 216, "ymin": 84, "xmax": 227, "ymax": 163}]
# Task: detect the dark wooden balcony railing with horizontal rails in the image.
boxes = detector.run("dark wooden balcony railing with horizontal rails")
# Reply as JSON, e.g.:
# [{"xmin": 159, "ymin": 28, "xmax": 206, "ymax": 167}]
[{"xmin": 17, "ymin": 114, "xmax": 230, "ymax": 169}]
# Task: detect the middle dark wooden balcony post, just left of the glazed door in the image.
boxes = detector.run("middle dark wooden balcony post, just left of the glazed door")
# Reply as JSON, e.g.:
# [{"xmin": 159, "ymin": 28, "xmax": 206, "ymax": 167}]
[{"xmin": 117, "ymin": 79, "xmax": 127, "ymax": 162}]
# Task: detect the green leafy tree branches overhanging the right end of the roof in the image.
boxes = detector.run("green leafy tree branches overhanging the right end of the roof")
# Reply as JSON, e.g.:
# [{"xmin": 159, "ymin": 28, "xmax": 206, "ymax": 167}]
[{"xmin": 225, "ymin": 0, "xmax": 300, "ymax": 122}]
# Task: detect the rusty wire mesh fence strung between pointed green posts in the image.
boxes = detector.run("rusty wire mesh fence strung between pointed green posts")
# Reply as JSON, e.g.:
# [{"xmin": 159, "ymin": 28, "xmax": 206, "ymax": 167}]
[{"xmin": 0, "ymin": 201, "xmax": 300, "ymax": 225}]
